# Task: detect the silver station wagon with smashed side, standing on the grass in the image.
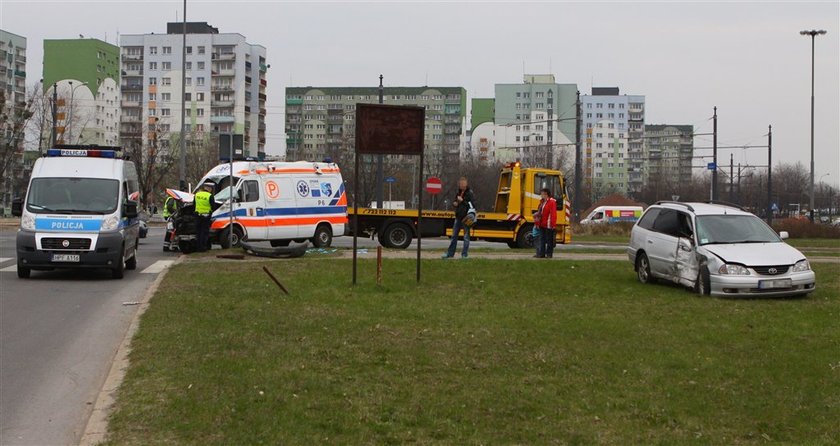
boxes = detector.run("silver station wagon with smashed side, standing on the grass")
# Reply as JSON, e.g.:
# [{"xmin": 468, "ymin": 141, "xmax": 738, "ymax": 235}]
[{"xmin": 627, "ymin": 201, "xmax": 816, "ymax": 296}]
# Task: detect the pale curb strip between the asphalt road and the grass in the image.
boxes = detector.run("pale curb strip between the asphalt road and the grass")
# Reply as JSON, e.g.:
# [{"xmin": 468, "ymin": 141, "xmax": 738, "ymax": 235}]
[{"xmin": 79, "ymin": 256, "xmax": 185, "ymax": 446}]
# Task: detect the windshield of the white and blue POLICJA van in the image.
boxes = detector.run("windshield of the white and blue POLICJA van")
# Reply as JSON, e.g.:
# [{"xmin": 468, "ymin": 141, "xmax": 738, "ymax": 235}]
[{"xmin": 26, "ymin": 178, "xmax": 120, "ymax": 214}]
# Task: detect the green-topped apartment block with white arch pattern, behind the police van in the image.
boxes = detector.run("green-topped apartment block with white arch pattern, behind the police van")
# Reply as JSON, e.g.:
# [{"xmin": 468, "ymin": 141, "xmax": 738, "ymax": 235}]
[{"xmin": 44, "ymin": 38, "xmax": 120, "ymax": 146}]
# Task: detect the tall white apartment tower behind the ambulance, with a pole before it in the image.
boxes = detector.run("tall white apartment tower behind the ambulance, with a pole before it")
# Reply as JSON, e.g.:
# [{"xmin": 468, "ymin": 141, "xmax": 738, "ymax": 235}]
[{"xmin": 120, "ymin": 22, "xmax": 268, "ymax": 157}]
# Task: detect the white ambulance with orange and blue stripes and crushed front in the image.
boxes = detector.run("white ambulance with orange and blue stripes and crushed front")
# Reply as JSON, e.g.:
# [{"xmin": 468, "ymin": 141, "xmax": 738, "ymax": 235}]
[{"xmin": 187, "ymin": 161, "xmax": 347, "ymax": 248}]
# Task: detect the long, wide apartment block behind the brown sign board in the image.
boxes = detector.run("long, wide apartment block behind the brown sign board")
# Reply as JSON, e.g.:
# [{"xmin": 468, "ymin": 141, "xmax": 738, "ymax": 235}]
[{"xmin": 286, "ymin": 87, "xmax": 467, "ymax": 161}]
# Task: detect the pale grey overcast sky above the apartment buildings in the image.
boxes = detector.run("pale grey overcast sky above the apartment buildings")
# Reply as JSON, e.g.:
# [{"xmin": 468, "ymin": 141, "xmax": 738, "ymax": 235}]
[{"xmin": 0, "ymin": 0, "xmax": 840, "ymax": 184}]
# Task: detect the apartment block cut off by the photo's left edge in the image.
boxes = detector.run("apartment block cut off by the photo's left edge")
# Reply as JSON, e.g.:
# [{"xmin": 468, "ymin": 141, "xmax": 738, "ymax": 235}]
[{"xmin": 0, "ymin": 30, "xmax": 31, "ymax": 214}]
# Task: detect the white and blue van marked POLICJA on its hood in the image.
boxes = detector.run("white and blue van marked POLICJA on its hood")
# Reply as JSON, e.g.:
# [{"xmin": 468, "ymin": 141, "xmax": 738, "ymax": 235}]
[{"xmin": 12, "ymin": 146, "xmax": 140, "ymax": 279}]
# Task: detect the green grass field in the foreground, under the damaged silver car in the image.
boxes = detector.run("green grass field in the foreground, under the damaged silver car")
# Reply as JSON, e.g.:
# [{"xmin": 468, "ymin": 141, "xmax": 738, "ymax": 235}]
[{"xmin": 109, "ymin": 259, "xmax": 840, "ymax": 445}]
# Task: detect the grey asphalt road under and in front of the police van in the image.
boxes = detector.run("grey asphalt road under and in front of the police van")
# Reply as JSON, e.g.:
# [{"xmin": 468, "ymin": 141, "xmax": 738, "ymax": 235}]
[{"xmin": 0, "ymin": 228, "xmax": 175, "ymax": 445}]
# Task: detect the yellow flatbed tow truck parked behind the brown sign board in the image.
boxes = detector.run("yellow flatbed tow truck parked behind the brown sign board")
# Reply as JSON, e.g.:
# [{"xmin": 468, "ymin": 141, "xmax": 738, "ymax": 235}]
[{"xmin": 347, "ymin": 161, "xmax": 572, "ymax": 249}]
